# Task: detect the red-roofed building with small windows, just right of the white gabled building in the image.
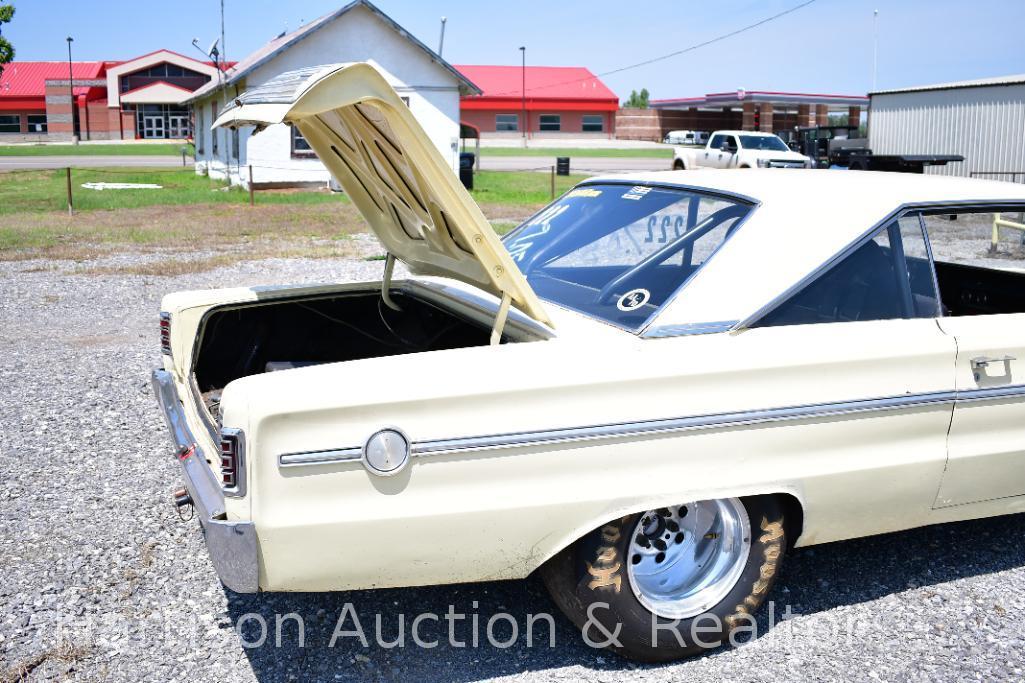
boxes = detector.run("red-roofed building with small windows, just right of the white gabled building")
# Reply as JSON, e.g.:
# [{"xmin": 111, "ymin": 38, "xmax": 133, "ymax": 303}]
[{"xmin": 455, "ymin": 65, "xmax": 619, "ymax": 137}]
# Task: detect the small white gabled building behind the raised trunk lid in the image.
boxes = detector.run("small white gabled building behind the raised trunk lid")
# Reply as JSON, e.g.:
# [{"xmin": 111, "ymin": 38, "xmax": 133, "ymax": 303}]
[{"xmin": 189, "ymin": 0, "xmax": 480, "ymax": 187}]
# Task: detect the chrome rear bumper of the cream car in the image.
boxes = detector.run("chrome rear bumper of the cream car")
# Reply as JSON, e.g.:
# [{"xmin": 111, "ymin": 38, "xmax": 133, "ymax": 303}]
[{"xmin": 153, "ymin": 370, "xmax": 259, "ymax": 593}]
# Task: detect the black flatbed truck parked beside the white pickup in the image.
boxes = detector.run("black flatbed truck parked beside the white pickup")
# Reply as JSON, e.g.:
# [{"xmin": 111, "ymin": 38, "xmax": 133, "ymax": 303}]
[{"xmin": 790, "ymin": 125, "xmax": 965, "ymax": 173}]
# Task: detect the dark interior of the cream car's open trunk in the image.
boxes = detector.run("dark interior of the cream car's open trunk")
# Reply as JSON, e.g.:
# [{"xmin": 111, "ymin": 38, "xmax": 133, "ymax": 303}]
[{"xmin": 194, "ymin": 290, "xmax": 511, "ymax": 421}]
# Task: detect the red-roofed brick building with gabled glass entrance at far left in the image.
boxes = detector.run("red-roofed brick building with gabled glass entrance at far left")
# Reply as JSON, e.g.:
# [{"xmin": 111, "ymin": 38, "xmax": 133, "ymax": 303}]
[{"xmin": 0, "ymin": 50, "xmax": 224, "ymax": 142}]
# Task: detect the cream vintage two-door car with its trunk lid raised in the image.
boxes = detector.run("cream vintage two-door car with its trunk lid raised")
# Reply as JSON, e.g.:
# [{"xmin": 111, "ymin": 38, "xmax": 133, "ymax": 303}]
[{"xmin": 153, "ymin": 64, "xmax": 1025, "ymax": 660}]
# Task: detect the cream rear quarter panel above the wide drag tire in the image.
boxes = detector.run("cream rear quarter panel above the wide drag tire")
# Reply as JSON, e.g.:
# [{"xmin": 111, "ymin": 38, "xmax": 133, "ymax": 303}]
[{"xmin": 224, "ymin": 321, "xmax": 953, "ymax": 591}]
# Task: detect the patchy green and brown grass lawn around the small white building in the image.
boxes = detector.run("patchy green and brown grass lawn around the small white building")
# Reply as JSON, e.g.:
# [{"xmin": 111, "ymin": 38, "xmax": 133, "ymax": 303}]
[{"xmin": 0, "ymin": 168, "xmax": 584, "ymax": 259}]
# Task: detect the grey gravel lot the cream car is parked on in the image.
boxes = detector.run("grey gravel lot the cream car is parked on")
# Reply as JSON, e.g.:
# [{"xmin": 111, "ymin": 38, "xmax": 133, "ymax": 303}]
[{"xmin": 0, "ymin": 256, "xmax": 1025, "ymax": 682}]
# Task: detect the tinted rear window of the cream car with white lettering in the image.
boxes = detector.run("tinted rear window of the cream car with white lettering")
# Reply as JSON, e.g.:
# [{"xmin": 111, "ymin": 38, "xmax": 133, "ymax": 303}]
[{"xmin": 505, "ymin": 184, "xmax": 751, "ymax": 331}]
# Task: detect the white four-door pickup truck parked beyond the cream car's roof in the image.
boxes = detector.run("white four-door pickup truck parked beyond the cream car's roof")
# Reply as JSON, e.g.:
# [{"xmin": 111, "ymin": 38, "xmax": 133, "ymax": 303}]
[{"xmin": 672, "ymin": 130, "xmax": 814, "ymax": 170}]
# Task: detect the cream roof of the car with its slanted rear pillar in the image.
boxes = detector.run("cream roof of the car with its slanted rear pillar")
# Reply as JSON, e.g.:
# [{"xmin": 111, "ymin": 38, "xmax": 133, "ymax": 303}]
[{"xmin": 585, "ymin": 168, "xmax": 1025, "ymax": 327}]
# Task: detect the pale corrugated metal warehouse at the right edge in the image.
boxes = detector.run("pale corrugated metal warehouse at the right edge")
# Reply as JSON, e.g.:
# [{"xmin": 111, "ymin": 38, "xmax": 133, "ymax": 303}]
[{"xmin": 868, "ymin": 74, "xmax": 1025, "ymax": 183}]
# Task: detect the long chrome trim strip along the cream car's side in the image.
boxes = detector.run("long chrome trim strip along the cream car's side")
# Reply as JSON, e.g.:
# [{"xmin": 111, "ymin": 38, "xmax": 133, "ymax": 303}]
[{"xmin": 278, "ymin": 386, "xmax": 963, "ymax": 467}]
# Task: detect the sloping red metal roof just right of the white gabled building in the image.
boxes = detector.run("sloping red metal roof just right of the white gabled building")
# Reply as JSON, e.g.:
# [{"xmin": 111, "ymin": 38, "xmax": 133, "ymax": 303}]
[{"xmin": 455, "ymin": 65, "xmax": 619, "ymax": 104}]
